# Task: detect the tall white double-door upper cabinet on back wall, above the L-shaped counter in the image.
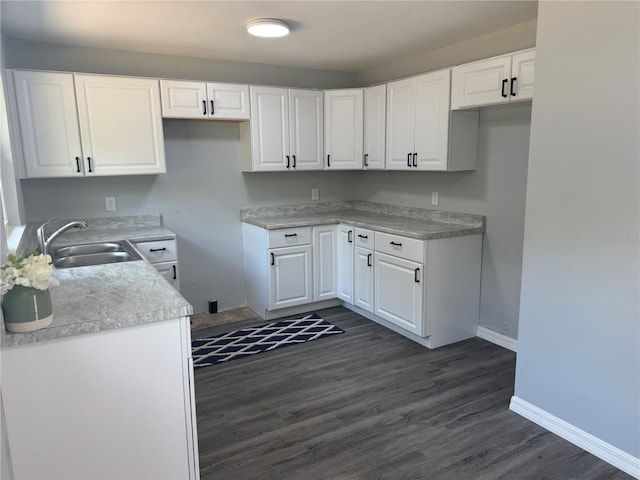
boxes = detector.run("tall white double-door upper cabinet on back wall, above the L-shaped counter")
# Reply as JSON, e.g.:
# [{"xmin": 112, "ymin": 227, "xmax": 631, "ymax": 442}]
[{"xmin": 240, "ymin": 86, "xmax": 323, "ymax": 172}]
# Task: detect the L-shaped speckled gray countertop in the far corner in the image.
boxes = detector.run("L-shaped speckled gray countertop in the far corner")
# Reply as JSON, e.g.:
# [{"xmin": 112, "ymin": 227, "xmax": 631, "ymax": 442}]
[{"xmin": 241, "ymin": 201, "xmax": 485, "ymax": 240}]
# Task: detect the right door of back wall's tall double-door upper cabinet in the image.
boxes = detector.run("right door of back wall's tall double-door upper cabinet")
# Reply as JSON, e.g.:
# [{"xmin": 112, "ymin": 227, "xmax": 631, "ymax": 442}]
[{"xmin": 289, "ymin": 89, "xmax": 324, "ymax": 170}]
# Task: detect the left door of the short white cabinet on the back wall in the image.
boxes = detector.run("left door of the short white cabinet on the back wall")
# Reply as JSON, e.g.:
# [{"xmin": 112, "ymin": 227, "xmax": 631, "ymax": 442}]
[{"xmin": 160, "ymin": 80, "xmax": 208, "ymax": 118}]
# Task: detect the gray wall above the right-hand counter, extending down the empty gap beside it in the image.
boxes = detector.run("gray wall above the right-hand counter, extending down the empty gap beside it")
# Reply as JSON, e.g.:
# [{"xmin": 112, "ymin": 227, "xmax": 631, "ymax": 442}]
[{"xmin": 357, "ymin": 104, "xmax": 531, "ymax": 338}]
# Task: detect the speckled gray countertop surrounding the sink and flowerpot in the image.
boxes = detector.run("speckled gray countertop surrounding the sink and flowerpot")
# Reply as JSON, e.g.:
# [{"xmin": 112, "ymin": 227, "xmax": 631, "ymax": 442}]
[{"xmin": 2, "ymin": 215, "xmax": 193, "ymax": 348}]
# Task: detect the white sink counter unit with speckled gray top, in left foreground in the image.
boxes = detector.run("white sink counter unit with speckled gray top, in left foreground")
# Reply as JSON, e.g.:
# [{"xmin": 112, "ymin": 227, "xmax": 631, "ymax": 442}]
[{"xmin": 2, "ymin": 218, "xmax": 199, "ymax": 479}]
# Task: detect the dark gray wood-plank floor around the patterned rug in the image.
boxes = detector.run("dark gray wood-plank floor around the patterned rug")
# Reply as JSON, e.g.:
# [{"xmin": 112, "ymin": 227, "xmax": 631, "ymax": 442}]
[{"xmin": 193, "ymin": 307, "xmax": 631, "ymax": 480}]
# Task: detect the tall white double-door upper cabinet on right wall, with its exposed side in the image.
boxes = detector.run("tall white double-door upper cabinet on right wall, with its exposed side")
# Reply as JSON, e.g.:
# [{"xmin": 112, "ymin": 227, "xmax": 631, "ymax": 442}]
[{"xmin": 386, "ymin": 69, "xmax": 478, "ymax": 171}]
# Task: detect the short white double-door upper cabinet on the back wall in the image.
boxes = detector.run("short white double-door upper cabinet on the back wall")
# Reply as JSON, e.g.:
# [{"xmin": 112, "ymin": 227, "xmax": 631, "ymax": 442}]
[{"xmin": 160, "ymin": 80, "xmax": 249, "ymax": 120}]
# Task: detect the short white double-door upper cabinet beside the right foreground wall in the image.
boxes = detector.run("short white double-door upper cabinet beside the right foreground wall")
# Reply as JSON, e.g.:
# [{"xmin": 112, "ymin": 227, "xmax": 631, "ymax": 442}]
[{"xmin": 451, "ymin": 49, "xmax": 536, "ymax": 110}]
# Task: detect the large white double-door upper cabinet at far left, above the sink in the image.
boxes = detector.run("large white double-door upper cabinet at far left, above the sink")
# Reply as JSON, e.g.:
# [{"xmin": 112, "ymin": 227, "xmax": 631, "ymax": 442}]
[{"xmin": 13, "ymin": 70, "xmax": 166, "ymax": 178}]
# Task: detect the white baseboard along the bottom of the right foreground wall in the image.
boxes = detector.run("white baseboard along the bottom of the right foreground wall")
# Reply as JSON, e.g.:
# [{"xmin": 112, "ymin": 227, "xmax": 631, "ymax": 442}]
[{"xmin": 509, "ymin": 395, "xmax": 640, "ymax": 479}]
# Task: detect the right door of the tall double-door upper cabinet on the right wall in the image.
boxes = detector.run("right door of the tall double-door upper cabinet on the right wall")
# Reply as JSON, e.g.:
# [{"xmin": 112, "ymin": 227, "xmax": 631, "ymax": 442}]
[{"xmin": 412, "ymin": 68, "xmax": 451, "ymax": 170}]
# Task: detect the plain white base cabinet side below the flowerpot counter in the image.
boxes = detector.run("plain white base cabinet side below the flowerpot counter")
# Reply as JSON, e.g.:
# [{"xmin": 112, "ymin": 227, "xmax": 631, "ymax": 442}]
[{"xmin": 2, "ymin": 317, "xmax": 200, "ymax": 480}]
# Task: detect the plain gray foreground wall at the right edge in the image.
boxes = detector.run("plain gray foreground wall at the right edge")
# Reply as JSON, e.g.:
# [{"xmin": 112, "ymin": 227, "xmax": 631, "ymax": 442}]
[{"xmin": 515, "ymin": 2, "xmax": 640, "ymax": 461}]
